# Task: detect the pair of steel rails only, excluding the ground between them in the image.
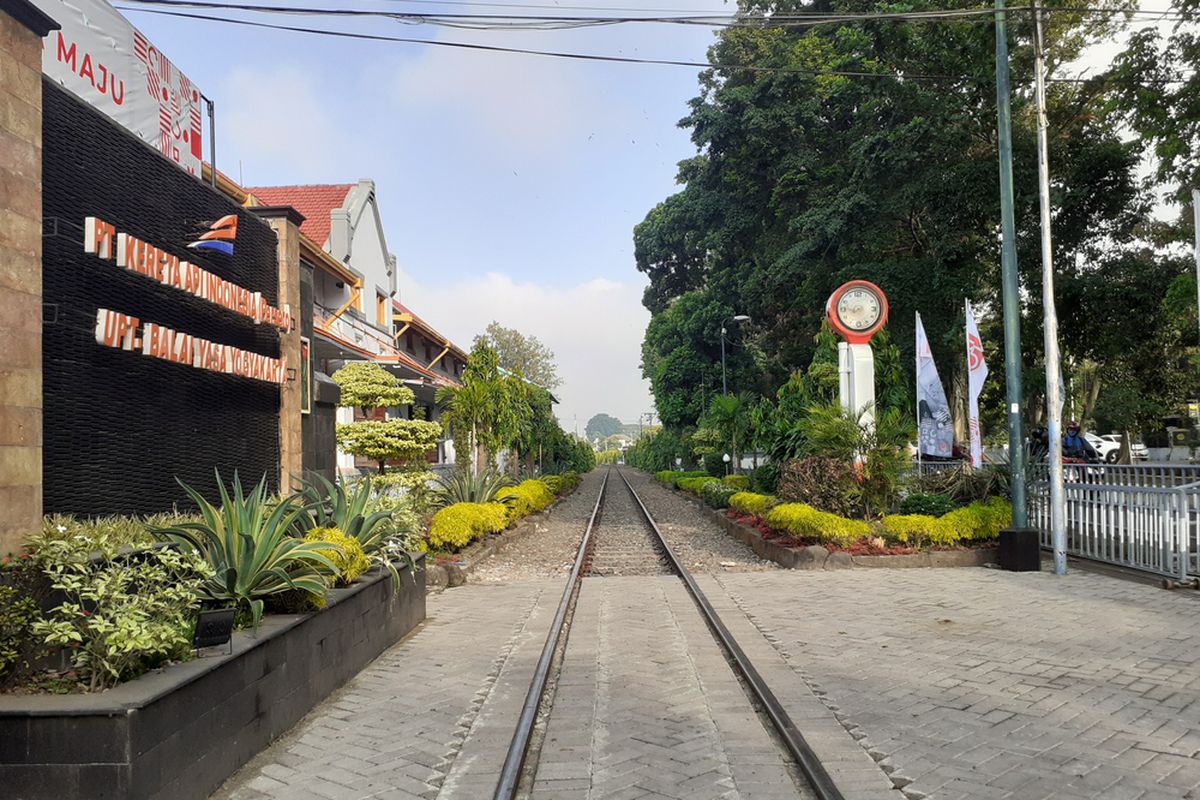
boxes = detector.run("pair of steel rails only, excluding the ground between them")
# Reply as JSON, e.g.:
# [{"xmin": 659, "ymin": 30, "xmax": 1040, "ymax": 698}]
[{"xmin": 493, "ymin": 467, "xmax": 844, "ymax": 800}]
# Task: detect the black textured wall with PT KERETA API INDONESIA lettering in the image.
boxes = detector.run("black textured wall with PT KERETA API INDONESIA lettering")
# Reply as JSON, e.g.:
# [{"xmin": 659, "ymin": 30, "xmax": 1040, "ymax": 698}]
[{"xmin": 41, "ymin": 80, "xmax": 280, "ymax": 515}]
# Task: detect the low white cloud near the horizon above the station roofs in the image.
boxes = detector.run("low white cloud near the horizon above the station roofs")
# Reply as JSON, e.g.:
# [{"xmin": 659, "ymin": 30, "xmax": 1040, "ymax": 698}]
[{"xmin": 400, "ymin": 271, "xmax": 654, "ymax": 433}]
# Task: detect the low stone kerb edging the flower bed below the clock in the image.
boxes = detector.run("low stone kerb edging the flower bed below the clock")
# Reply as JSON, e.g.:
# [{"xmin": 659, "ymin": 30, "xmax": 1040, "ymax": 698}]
[{"xmin": 660, "ymin": 483, "xmax": 996, "ymax": 570}]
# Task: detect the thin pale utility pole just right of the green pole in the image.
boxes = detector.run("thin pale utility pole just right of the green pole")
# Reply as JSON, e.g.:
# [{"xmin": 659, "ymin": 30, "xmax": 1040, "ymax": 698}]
[{"xmin": 1033, "ymin": 0, "xmax": 1067, "ymax": 575}]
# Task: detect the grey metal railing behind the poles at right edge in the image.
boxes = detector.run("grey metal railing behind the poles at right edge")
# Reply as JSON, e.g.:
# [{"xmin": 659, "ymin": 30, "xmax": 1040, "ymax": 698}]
[{"xmin": 1027, "ymin": 479, "xmax": 1200, "ymax": 581}]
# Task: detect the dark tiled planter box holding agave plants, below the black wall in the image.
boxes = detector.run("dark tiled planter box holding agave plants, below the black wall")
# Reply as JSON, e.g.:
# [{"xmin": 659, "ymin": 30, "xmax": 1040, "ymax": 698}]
[{"xmin": 0, "ymin": 557, "xmax": 425, "ymax": 800}]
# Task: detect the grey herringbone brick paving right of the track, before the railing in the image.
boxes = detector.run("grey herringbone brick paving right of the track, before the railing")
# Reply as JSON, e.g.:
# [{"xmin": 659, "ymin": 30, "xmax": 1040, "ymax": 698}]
[{"xmin": 713, "ymin": 569, "xmax": 1200, "ymax": 800}]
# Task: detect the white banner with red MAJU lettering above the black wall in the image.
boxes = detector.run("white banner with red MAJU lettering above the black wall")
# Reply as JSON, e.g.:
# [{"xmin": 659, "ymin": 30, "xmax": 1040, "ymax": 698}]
[{"xmin": 32, "ymin": 0, "xmax": 204, "ymax": 176}]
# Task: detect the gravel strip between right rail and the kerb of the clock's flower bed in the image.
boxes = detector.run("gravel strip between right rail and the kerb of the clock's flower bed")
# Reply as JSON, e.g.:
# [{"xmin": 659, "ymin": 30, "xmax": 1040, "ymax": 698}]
[{"xmin": 613, "ymin": 469, "xmax": 781, "ymax": 573}]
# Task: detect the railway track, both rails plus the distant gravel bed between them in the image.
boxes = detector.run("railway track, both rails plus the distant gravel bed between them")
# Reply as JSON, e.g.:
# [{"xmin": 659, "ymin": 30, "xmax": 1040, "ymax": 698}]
[{"xmin": 493, "ymin": 468, "xmax": 842, "ymax": 800}]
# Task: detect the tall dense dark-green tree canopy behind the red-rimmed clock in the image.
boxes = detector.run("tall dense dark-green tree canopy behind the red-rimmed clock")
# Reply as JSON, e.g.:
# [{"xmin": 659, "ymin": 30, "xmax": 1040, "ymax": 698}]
[{"xmin": 634, "ymin": 0, "xmax": 1185, "ymax": 438}]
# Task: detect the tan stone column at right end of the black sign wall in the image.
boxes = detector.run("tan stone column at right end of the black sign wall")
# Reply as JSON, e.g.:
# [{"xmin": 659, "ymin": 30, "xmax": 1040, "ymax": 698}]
[{"xmin": 250, "ymin": 205, "xmax": 304, "ymax": 494}]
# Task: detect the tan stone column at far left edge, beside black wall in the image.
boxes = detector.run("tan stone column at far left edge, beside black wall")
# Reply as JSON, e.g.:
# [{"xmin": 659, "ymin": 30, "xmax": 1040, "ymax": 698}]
[{"xmin": 0, "ymin": 0, "xmax": 59, "ymax": 555}]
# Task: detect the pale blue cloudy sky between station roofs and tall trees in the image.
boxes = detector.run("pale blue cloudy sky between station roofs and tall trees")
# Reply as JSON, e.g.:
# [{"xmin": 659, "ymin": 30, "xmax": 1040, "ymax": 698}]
[{"xmin": 115, "ymin": 0, "xmax": 733, "ymax": 432}]
